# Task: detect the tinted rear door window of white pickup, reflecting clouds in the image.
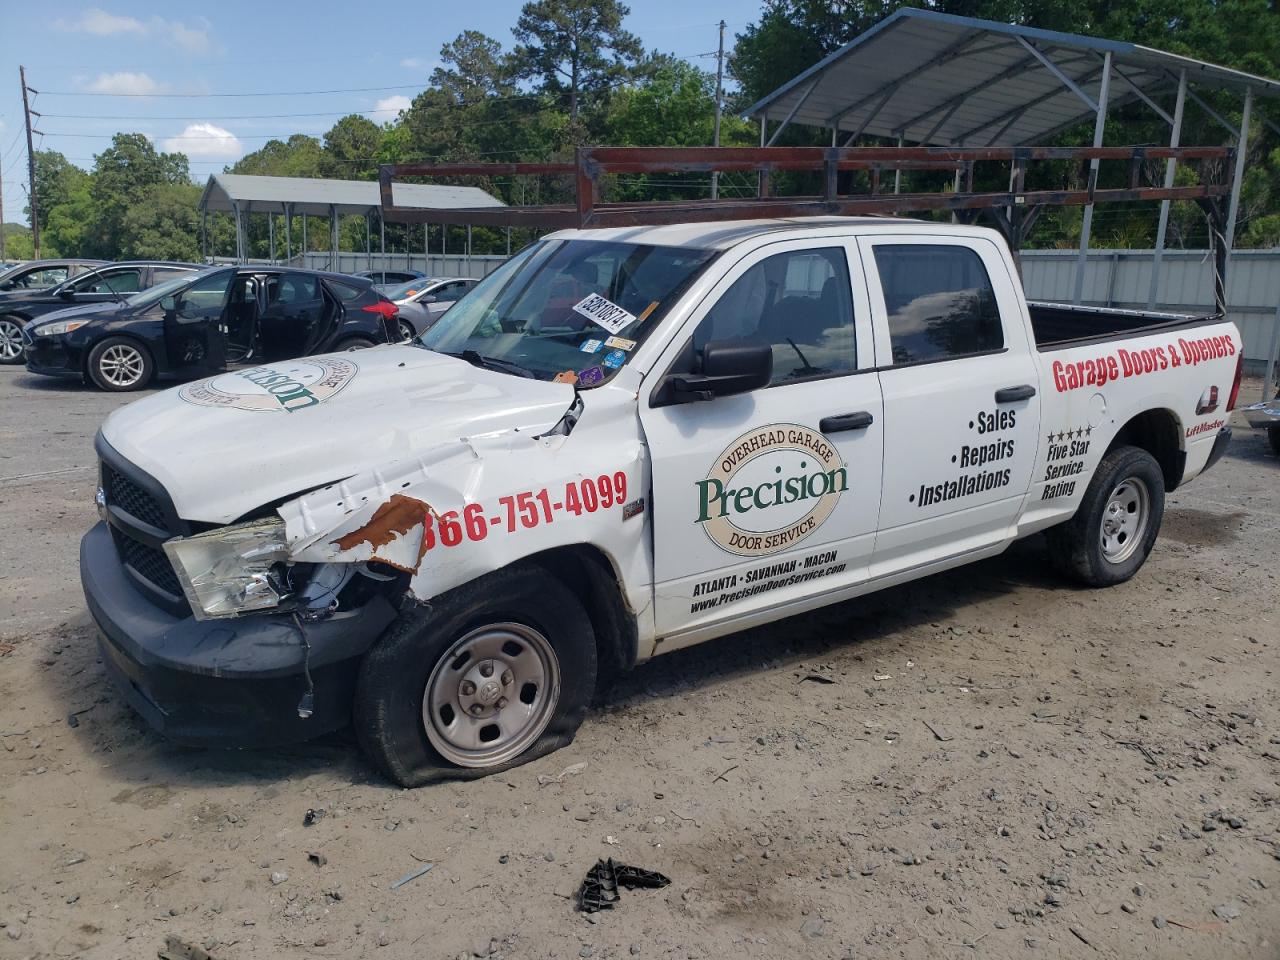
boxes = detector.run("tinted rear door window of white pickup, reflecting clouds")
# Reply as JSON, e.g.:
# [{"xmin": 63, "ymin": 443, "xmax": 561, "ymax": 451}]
[{"xmin": 874, "ymin": 243, "xmax": 1005, "ymax": 366}]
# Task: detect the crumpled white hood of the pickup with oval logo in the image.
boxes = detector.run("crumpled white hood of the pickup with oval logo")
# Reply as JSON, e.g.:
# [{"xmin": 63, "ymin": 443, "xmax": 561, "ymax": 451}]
[{"xmin": 102, "ymin": 346, "xmax": 573, "ymax": 524}]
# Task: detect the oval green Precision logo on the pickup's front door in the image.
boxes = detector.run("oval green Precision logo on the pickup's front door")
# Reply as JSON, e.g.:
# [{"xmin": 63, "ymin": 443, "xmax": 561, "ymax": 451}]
[{"xmin": 694, "ymin": 424, "xmax": 849, "ymax": 557}]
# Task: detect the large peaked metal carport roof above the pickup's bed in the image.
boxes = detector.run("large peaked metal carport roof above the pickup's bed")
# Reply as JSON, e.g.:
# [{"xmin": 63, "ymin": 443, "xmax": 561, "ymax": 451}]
[{"xmin": 745, "ymin": 8, "xmax": 1280, "ymax": 147}]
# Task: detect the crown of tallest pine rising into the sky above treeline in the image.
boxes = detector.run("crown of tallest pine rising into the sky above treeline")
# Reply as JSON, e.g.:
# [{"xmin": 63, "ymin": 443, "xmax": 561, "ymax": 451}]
[{"xmin": 512, "ymin": 0, "xmax": 644, "ymax": 124}]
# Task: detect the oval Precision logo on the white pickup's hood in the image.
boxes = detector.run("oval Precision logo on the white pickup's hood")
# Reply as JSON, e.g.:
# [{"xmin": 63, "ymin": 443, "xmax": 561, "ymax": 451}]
[{"xmin": 178, "ymin": 357, "xmax": 360, "ymax": 413}]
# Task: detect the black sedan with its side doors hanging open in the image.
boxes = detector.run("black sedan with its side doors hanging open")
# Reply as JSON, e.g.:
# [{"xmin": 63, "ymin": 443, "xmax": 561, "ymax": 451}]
[{"xmin": 23, "ymin": 266, "xmax": 397, "ymax": 390}]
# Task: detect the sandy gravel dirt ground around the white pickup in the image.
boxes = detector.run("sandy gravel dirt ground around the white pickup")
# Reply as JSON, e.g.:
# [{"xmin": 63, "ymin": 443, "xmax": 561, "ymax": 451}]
[{"xmin": 0, "ymin": 367, "xmax": 1280, "ymax": 960}]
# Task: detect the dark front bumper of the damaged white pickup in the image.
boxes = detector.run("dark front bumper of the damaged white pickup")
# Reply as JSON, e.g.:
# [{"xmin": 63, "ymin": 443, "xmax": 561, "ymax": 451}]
[{"xmin": 81, "ymin": 524, "xmax": 396, "ymax": 746}]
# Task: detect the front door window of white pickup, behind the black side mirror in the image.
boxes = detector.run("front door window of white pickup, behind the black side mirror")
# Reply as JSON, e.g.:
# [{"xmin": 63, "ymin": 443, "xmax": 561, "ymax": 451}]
[{"xmin": 694, "ymin": 247, "xmax": 858, "ymax": 385}]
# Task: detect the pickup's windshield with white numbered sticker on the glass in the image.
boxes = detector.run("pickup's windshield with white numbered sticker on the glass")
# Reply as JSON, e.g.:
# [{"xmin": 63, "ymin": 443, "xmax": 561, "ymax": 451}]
[{"xmin": 419, "ymin": 239, "xmax": 716, "ymax": 387}]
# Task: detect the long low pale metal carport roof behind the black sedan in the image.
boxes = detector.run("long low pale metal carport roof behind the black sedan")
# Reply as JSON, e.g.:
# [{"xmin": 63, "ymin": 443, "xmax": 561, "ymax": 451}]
[{"xmin": 200, "ymin": 173, "xmax": 504, "ymax": 216}]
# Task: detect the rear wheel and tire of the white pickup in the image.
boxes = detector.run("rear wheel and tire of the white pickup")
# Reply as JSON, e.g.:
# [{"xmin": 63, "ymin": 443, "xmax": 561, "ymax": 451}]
[{"xmin": 1046, "ymin": 447, "xmax": 1165, "ymax": 586}]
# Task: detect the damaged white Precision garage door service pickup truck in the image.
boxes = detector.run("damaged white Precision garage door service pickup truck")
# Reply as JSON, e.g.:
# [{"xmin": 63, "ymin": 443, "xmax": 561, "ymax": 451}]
[{"xmin": 81, "ymin": 218, "xmax": 1240, "ymax": 786}]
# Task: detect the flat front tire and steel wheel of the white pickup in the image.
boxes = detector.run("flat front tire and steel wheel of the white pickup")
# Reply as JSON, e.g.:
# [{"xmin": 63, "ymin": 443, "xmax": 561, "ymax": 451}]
[{"xmin": 355, "ymin": 564, "xmax": 596, "ymax": 787}]
